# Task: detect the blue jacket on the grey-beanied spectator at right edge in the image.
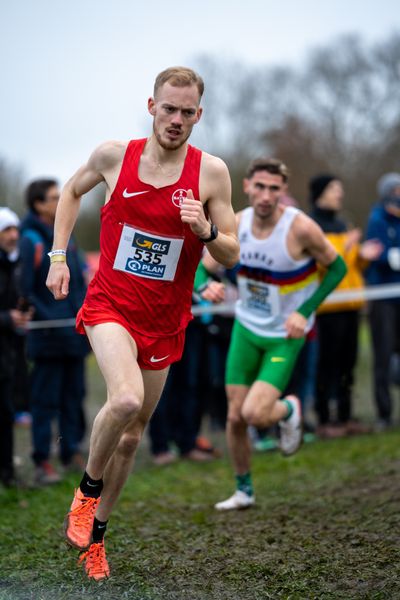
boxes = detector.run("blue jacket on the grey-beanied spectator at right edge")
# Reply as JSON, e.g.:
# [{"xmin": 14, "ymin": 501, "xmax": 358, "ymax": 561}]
[{"xmin": 365, "ymin": 204, "xmax": 400, "ymax": 285}]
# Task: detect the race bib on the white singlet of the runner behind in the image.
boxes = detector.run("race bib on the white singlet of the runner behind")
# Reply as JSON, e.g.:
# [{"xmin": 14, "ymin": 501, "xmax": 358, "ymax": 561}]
[{"xmin": 238, "ymin": 277, "xmax": 281, "ymax": 318}]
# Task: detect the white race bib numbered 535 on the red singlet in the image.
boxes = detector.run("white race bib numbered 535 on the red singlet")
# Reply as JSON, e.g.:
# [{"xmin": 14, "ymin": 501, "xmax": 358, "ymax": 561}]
[{"xmin": 113, "ymin": 225, "xmax": 183, "ymax": 281}]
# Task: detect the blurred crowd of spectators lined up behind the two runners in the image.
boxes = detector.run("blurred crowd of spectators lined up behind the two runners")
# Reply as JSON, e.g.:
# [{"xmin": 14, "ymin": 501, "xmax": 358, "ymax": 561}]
[{"xmin": 0, "ymin": 165, "xmax": 400, "ymax": 486}]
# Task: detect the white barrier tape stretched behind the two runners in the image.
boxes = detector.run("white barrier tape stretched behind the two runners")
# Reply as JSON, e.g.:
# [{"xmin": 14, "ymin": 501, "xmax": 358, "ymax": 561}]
[{"xmin": 28, "ymin": 283, "xmax": 400, "ymax": 329}]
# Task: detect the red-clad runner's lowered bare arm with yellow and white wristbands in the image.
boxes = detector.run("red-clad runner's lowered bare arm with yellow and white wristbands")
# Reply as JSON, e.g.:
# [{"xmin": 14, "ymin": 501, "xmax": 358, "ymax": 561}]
[{"xmin": 46, "ymin": 142, "xmax": 123, "ymax": 300}]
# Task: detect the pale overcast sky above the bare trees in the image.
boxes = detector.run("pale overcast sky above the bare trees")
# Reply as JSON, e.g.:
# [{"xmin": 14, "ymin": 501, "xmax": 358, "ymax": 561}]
[{"xmin": 0, "ymin": 0, "xmax": 400, "ymax": 183}]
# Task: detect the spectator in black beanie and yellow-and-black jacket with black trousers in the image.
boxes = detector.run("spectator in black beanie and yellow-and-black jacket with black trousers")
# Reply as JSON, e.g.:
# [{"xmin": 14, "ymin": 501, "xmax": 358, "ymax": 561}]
[{"xmin": 309, "ymin": 174, "xmax": 382, "ymax": 437}]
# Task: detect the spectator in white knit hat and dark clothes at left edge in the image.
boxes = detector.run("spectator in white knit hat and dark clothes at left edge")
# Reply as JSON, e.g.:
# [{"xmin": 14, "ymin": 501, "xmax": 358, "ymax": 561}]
[{"xmin": 0, "ymin": 207, "xmax": 32, "ymax": 487}]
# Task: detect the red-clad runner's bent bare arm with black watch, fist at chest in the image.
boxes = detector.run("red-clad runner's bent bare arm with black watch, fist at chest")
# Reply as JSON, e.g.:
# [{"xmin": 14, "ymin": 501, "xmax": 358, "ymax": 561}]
[{"xmin": 181, "ymin": 153, "xmax": 239, "ymax": 267}]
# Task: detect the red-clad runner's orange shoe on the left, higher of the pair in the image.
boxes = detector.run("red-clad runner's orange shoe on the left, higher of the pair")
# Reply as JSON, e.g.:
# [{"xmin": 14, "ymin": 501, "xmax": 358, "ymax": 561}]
[{"xmin": 64, "ymin": 488, "xmax": 100, "ymax": 550}]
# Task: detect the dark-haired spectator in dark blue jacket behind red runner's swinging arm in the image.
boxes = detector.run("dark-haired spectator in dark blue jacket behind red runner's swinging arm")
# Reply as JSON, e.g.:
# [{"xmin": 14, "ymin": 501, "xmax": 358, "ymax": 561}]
[{"xmin": 21, "ymin": 179, "xmax": 88, "ymax": 485}]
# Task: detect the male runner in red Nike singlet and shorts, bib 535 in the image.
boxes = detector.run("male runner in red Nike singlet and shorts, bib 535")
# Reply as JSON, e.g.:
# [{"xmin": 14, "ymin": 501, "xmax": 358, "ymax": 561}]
[{"xmin": 47, "ymin": 67, "xmax": 239, "ymax": 580}]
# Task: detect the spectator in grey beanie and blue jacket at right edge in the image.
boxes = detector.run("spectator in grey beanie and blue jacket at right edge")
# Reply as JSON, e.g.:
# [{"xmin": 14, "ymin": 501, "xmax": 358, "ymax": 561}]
[{"xmin": 366, "ymin": 173, "xmax": 400, "ymax": 429}]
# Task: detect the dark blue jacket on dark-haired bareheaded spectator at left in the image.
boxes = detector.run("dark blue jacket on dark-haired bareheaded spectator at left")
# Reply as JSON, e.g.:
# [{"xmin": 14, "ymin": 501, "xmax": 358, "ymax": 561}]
[{"xmin": 20, "ymin": 212, "xmax": 88, "ymax": 358}]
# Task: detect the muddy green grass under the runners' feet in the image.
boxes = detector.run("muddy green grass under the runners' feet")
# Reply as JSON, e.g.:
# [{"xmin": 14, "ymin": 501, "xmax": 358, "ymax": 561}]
[{"xmin": 0, "ymin": 431, "xmax": 400, "ymax": 600}]
